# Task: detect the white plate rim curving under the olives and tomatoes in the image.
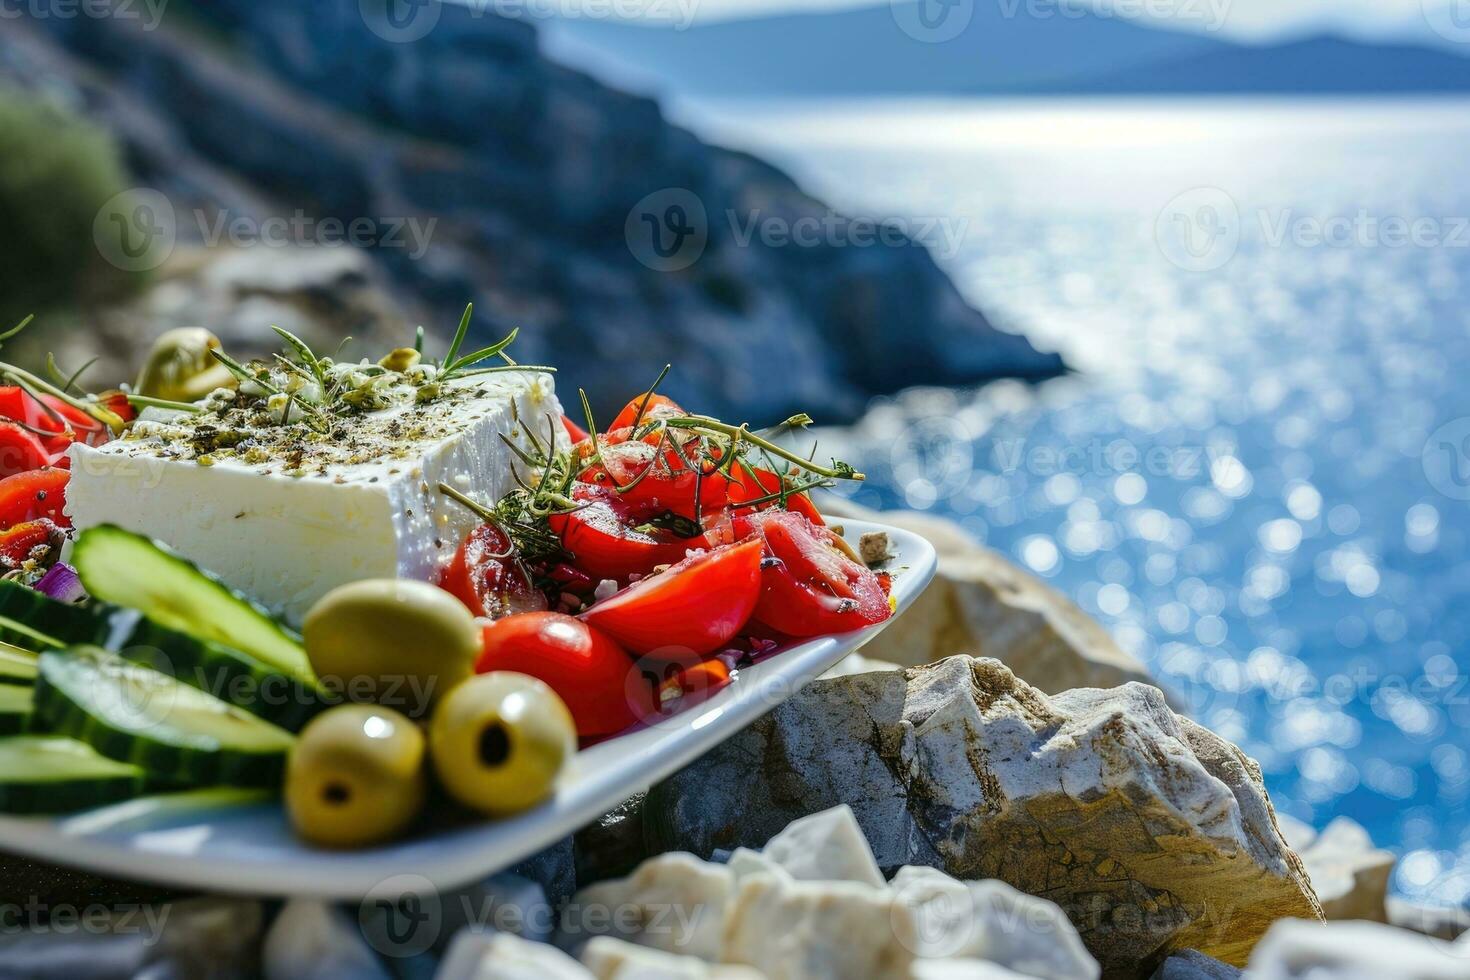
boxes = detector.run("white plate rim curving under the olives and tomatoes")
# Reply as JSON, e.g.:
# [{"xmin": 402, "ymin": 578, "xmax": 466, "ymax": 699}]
[{"xmin": 0, "ymin": 520, "xmax": 936, "ymax": 901}]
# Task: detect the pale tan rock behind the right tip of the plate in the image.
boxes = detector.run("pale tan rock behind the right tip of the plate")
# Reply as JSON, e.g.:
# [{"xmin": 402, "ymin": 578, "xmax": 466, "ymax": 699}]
[{"xmin": 822, "ymin": 495, "xmax": 1154, "ymax": 693}]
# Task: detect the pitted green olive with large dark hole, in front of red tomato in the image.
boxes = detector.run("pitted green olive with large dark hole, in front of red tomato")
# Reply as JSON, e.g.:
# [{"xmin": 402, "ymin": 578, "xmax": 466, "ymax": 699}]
[{"xmin": 429, "ymin": 671, "xmax": 576, "ymax": 817}]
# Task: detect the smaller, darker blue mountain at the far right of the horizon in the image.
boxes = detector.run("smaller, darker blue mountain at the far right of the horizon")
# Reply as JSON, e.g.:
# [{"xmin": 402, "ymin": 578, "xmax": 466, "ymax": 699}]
[{"xmin": 1053, "ymin": 37, "xmax": 1470, "ymax": 96}]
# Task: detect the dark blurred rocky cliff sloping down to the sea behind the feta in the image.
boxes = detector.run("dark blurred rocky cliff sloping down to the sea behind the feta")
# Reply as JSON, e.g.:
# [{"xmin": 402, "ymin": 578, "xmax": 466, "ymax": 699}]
[{"xmin": 0, "ymin": 0, "xmax": 1061, "ymax": 422}]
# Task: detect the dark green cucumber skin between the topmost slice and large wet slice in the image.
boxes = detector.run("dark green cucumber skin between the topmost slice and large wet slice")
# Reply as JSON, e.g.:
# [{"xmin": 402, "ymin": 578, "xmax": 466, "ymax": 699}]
[{"xmin": 118, "ymin": 616, "xmax": 329, "ymax": 732}]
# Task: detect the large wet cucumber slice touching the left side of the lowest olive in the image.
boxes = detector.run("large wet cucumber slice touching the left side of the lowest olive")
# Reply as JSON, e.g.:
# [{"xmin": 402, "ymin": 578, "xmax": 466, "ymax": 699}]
[{"xmin": 35, "ymin": 646, "xmax": 294, "ymax": 788}]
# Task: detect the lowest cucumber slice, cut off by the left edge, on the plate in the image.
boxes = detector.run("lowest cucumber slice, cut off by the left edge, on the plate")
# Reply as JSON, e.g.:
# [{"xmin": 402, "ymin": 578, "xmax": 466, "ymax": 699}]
[{"xmin": 0, "ymin": 735, "xmax": 144, "ymax": 814}]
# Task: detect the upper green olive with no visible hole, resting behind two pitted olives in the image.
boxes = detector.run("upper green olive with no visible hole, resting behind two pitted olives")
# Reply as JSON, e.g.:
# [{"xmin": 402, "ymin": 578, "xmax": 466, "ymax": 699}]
[{"xmin": 303, "ymin": 579, "xmax": 481, "ymax": 717}]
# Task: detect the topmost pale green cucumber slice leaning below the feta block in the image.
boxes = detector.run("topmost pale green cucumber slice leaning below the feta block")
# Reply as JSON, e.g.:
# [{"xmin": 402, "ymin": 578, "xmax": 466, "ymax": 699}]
[{"xmin": 72, "ymin": 525, "xmax": 316, "ymax": 685}]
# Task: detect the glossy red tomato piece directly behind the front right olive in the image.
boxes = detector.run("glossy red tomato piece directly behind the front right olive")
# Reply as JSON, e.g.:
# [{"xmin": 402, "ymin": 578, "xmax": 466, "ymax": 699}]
[{"xmin": 475, "ymin": 613, "xmax": 654, "ymax": 738}]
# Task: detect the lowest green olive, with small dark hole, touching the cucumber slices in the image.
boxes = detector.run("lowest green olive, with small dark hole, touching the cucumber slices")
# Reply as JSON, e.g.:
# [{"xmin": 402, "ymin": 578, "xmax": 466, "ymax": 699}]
[{"xmin": 285, "ymin": 704, "xmax": 426, "ymax": 848}]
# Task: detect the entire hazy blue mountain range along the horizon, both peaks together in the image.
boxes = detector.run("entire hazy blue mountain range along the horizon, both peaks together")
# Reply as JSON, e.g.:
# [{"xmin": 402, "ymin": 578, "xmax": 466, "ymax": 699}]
[{"xmin": 545, "ymin": 0, "xmax": 1470, "ymax": 97}]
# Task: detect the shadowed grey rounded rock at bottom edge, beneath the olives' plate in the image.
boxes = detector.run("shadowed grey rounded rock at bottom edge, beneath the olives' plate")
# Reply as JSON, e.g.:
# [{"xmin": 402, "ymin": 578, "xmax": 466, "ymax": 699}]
[{"xmin": 260, "ymin": 899, "xmax": 388, "ymax": 980}]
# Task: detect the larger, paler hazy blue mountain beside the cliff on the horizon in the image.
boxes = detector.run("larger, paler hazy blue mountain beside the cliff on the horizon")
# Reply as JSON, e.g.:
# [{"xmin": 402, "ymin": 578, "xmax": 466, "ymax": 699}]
[{"xmin": 544, "ymin": 0, "xmax": 1229, "ymax": 97}]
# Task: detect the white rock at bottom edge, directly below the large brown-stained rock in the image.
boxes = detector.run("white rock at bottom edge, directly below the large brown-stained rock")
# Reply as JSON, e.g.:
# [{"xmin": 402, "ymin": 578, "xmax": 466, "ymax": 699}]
[{"xmin": 892, "ymin": 867, "xmax": 1101, "ymax": 980}]
